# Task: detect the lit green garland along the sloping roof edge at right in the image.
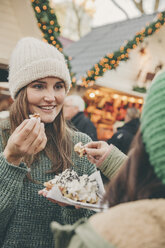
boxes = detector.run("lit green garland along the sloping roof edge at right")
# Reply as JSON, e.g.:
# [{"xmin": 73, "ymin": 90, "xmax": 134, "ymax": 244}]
[{"xmin": 81, "ymin": 11, "xmax": 165, "ymax": 88}]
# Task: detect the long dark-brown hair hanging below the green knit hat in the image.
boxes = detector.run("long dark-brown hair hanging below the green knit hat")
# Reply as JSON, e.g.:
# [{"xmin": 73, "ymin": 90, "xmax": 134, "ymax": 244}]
[{"xmin": 104, "ymin": 129, "xmax": 165, "ymax": 207}]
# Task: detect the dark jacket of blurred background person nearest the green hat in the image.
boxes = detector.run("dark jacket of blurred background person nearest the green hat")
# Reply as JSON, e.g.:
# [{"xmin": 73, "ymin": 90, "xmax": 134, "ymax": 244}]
[{"xmin": 107, "ymin": 118, "xmax": 140, "ymax": 154}]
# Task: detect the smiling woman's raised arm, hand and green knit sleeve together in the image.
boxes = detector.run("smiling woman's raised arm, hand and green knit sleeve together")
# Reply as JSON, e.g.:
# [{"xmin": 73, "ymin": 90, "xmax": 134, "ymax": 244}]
[{"xmin": 0, "ymin": 120, "xmax": 46, "ymax": 238}]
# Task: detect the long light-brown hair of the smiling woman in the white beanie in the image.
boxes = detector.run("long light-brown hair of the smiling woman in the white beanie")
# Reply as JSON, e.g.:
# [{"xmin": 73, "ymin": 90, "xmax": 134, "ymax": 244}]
[{"xmin": 10, "ymin": 87, "xmax": 73, "ymax": 172}]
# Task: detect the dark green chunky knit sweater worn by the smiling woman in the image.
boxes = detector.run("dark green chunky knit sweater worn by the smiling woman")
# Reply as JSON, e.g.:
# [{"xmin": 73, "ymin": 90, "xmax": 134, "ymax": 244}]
[{"xmin": 0, "ymin": 119, "xmax": 96, "ymax": 248}]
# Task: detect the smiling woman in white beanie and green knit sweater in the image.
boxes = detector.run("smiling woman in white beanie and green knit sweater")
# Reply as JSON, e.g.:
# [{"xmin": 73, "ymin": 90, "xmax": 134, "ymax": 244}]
[{"xmin": 0, "ymin": 37, "xmax": 104, "ymax": 248}]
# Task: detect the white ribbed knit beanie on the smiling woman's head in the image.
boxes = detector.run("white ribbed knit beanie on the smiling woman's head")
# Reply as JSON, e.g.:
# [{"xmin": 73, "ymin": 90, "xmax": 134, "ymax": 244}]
[{"xmin": 9, "ymin": 37, "xmax": 71, "ymax": 99}]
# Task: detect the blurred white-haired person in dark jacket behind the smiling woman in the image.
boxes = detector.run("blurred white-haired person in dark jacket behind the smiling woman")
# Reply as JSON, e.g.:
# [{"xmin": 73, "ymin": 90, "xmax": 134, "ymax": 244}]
[{"xmin": 64, "ymin": 95, "xmax": 97, "ymax": 141}]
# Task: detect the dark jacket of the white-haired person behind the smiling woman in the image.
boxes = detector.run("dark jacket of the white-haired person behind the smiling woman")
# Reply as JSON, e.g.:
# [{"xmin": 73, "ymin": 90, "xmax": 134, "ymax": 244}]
[{"xmin": 71, "ymin": 112, "xmax": 97, "ymax": 141}]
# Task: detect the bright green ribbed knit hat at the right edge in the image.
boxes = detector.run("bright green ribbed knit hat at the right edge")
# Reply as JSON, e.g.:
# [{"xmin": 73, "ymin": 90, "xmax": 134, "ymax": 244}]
[{"xmin": 141, "ymin": 71, "xmax": 165, "ymax": 184}]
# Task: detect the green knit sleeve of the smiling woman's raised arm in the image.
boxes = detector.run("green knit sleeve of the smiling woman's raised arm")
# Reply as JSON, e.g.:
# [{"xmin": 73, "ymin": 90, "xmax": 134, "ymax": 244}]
[{"xmin": 0, "ymin": 126, "xmax": 28, "ymax": 240}]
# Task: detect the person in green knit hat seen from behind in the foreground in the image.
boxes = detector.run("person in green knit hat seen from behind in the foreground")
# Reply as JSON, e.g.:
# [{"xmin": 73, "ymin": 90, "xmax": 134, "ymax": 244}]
[{"xmin": 51, "ymin": 69, "xmax": 165, "ymax": 248}]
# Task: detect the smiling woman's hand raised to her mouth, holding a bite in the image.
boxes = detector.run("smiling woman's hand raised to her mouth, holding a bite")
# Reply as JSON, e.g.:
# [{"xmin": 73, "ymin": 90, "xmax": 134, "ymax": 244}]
[{"xmin": 4, "ymin": 119, "xmax": 47, "ymax": 165}]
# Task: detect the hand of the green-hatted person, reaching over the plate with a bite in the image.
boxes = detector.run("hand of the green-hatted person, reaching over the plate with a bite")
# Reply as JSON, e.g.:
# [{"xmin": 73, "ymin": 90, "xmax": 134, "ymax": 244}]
[{"xmin": 84, "ymin": 141, "xmax": 112, "ymax": 166}]
